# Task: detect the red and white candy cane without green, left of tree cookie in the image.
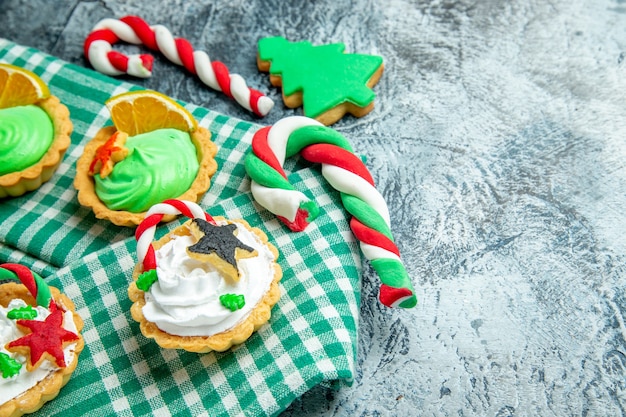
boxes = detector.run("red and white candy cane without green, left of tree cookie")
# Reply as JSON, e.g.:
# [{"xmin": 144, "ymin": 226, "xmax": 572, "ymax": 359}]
[{"xmin": 84, "ymin": 16, "xmax": 274, "ymax": 116}]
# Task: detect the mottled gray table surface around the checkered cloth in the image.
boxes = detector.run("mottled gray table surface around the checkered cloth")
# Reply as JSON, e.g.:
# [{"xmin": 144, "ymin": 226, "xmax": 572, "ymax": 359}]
[{"xmin": 0, "ymin": 0, "xmax": 626, "ymax": 417}]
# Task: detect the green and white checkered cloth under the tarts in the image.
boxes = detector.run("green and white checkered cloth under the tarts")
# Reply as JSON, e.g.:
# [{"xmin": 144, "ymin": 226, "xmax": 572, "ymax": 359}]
[{"xmin": 0, "ymin": 39, "xmax": 361, "ymax": 416}]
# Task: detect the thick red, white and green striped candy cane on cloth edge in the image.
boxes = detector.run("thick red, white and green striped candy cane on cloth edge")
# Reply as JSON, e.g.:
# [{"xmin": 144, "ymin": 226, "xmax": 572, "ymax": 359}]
[{"xmin": 245, "ymin": 116, "xmax": 417, "ymax": 308}]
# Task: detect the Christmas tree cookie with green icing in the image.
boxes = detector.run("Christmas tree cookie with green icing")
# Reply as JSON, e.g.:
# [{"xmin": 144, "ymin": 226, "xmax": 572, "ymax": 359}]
[{"xmin": 257, "ymin": 37, "xmax": 383, "ymax": 126}]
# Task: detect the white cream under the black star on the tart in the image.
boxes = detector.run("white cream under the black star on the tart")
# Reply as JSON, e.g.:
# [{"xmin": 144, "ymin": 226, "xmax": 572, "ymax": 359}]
[{"xmin": 142, "ymin": 222, "xmax": 275, "ymax": 336}]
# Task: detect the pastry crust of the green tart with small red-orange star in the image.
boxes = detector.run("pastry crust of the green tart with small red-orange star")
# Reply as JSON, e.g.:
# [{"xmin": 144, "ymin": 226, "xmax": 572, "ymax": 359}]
[{"xmin": 74, "ymin": 126, "xmax": 217, "ymax": 227}]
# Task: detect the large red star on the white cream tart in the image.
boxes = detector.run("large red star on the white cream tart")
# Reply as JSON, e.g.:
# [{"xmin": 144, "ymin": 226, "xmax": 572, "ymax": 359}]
[{"xmin": 7, "ymin": 306, "xmax": 78, "ymax": 371}]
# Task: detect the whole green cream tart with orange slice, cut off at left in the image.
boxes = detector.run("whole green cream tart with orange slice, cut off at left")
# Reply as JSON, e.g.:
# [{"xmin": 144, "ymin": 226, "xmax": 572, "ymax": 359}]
[{"xmin": 0, "ymin": 63, "xmax": 73, "ymax": 198}]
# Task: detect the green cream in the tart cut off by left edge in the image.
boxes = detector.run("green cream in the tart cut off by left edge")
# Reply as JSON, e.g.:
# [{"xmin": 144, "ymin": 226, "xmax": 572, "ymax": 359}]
[{"xmin": 0, "ymin": 105, "xmax": 54, "ymax": 175}]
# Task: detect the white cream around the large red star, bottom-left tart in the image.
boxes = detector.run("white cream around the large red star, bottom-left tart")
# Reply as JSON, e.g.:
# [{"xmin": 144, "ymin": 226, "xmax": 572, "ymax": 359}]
[{"xmin": 0, "ymin": 299, "xmax": 78, "ymax": 405}]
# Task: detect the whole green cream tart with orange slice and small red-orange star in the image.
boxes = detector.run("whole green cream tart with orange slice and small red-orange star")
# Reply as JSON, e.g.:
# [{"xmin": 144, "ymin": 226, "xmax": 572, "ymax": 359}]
[{"xmin": 74, "ymin": 91, "xmax": 217, "ymax": 226}]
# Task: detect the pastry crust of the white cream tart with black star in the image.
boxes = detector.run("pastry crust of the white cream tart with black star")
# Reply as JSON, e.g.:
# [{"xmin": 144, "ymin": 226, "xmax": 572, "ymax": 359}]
[{"xmin": 128, "ymin": 217, "xmax": 283, "ymax": 353}]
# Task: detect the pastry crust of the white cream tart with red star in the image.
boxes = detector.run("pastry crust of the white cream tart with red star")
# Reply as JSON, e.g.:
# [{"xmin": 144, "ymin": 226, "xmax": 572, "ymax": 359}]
[{"xmin": 0, "ymin": 282, "xmax": 85, "ymax": 417}]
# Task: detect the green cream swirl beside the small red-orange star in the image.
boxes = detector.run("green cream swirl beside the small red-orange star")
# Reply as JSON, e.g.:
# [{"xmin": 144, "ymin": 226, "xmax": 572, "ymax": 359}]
[{"xmin": 94, "ymin": 129, "xmax": 200, "ymax": 213}]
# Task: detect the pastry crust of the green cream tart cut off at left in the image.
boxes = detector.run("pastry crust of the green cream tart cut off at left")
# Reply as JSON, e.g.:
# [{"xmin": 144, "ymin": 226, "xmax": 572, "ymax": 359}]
[{"xmin": 0, "ymin": 96, "xmax": 74, "ymax": 198}]
